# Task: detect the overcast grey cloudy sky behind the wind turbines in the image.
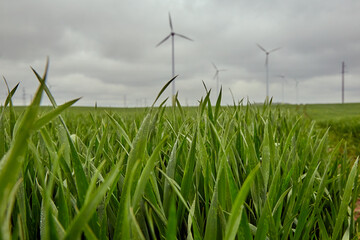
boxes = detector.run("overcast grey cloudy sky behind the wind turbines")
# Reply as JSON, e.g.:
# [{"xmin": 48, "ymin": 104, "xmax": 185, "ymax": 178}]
[{"xmin": 0, "ymin": 0, "xmax": 360, "ymax": 107}]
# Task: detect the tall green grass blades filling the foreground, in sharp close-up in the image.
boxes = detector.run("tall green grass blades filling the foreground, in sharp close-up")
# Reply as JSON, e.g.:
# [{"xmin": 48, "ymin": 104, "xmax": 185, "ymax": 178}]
[{"xmin": 0, "ymin": 62, "xmax": 359, "ymax": 239}]
